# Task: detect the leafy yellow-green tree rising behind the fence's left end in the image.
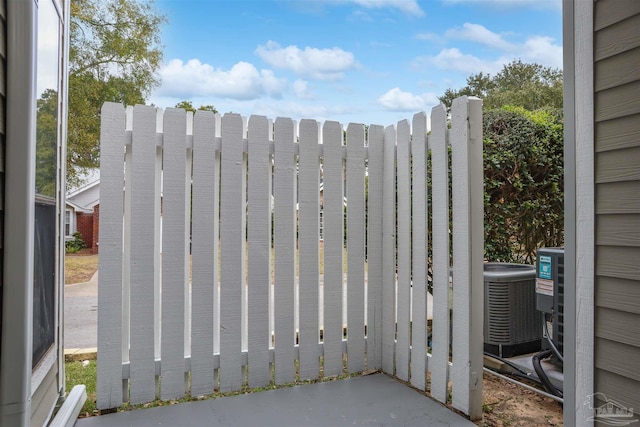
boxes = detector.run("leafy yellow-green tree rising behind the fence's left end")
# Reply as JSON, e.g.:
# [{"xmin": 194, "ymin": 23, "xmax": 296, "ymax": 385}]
[{"xmin": 67, "ymin": 0, "xmax": 165, "ymax": 184}]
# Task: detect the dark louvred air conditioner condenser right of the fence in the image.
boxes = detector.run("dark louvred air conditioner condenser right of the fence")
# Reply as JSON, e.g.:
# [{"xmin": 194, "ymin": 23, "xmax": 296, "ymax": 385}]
[{"xmin": 484, "ymin": 263, "xmax": 542, "ymax": 357}]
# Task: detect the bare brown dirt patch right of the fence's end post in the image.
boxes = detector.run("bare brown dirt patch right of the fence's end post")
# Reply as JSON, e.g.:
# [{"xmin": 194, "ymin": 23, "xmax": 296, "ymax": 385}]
[{"xmin": 477, "ymin": 373, "xmax": 563, "ymax": 427}]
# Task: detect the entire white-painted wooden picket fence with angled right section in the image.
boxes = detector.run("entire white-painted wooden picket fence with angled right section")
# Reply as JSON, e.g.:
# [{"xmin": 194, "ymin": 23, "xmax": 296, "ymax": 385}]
[{"xmin": 97, "ymin": 97, "xmax": 483, "ymax": 418}]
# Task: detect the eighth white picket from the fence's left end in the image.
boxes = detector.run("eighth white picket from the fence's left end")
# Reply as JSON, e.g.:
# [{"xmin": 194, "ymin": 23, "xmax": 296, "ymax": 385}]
[{"xmin": 298, "ymin": 120, "xmax": 320, "ymax": 380}]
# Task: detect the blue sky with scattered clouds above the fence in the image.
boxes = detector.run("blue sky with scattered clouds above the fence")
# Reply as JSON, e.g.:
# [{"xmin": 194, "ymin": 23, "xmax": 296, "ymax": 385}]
[{"xmin": 149, "ymin": 0, "xmax": 562, "ymax": 125}]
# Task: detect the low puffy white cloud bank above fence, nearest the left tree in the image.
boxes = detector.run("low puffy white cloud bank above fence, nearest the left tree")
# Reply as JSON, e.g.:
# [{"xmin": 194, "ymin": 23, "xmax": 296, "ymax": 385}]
[{"xmin": 157, "ymin": 59, "xmax": 286, "ymax": 99}]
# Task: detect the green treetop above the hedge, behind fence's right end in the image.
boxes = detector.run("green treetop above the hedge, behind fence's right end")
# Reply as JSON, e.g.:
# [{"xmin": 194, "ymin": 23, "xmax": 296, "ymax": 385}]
[{"xmin": 438, "ymin": 60, "xmax": 562, "ymax": 111}]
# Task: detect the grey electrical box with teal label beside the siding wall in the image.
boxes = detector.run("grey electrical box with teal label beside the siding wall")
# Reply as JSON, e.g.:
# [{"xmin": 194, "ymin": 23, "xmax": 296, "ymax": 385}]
[{"xmin": 536, "ymin": 248, "xmax": 564, "ymax": 366}]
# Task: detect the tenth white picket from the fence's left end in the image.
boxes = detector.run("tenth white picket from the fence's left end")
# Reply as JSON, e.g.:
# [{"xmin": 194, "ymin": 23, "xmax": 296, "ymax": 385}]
[{"xmin": 346, "ymin": 123, "xmax": 365, "ymax": 372}]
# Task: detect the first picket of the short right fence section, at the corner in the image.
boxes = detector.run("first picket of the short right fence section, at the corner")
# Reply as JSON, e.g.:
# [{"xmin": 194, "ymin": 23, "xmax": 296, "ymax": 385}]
[{"xmin": 382, "ymin": 126, "xmax": 396, "ymax": 375}]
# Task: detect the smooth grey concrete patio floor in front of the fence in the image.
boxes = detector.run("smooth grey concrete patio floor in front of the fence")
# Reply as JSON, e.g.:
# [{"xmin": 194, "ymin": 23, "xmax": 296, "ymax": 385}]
[{"xmin": 75, "ymin": 374, "xmax": 475, "ymax": 427}]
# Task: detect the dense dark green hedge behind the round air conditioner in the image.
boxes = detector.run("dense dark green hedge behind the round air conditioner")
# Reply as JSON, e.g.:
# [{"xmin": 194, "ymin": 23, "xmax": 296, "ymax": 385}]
[{"xmin": 483, "ymin": 107, "xmax": 564, "ymax": 263}]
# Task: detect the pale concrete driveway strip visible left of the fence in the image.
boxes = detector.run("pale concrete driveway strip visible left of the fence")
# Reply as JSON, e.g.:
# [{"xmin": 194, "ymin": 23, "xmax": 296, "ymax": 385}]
[{"xmin": 64, "ymin": 271, "xmax": 98, "ymax": 349}]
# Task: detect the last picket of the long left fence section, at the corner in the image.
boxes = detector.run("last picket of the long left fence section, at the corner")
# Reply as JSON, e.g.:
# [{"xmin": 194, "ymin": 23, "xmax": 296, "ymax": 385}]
[{"xmin": 367, "ymin": 125, "xmax": 384, "ymax": 370}]
